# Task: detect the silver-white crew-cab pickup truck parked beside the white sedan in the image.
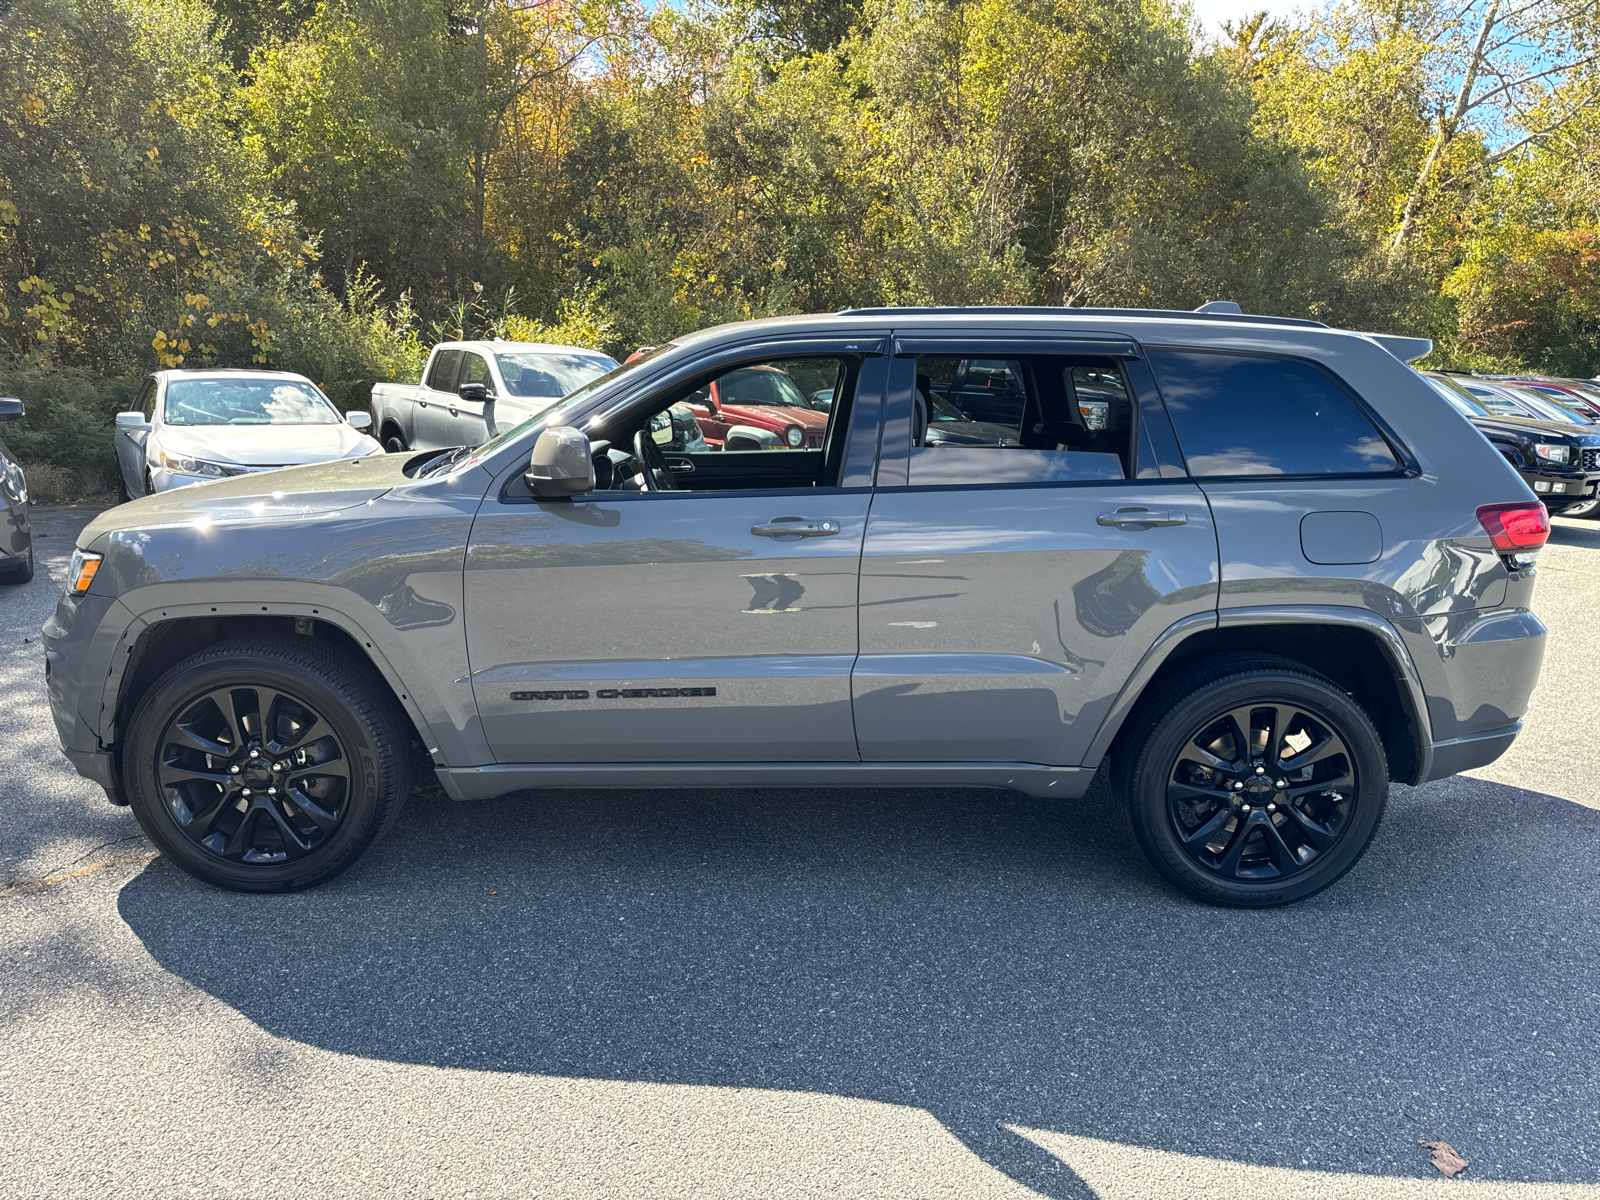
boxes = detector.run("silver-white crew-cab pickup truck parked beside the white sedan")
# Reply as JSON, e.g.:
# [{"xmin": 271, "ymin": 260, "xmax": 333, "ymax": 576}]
[{"xmin": 373, "ymin": 341, "xmax": 616, "ymax": 454}]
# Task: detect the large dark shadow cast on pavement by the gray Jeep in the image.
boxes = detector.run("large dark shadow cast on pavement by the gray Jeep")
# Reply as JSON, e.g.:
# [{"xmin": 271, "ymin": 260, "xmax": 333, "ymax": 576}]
[{"xmin": 120, "ymin": 778, "xmax": 1600, "ymax": 1197}]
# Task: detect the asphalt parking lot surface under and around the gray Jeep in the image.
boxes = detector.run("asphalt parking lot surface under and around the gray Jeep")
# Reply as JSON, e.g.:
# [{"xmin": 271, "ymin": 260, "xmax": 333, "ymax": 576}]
[{"xmin": 0, "ymin": 509, "xmax": 1600, "ymax": 1200}]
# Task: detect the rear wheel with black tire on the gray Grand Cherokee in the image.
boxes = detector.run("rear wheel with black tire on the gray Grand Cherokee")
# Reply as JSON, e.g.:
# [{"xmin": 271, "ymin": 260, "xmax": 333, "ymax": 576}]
[{"xmin": 1114, "ymin": 654, "xmax": 1389, "ymax": 909}]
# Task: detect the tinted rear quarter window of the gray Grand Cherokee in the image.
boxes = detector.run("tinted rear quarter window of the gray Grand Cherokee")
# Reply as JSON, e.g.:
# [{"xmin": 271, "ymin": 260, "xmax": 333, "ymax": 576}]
[{"xmin": 1150, "ymin": 350, "xmax": 1400, "ymax": 475}]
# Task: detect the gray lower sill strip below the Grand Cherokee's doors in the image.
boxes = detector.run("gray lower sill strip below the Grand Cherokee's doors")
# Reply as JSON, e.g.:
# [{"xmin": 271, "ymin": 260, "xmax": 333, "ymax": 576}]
[{"xmin": 438, "ymin": 763, "xmax": 1094, "ymax": 800}]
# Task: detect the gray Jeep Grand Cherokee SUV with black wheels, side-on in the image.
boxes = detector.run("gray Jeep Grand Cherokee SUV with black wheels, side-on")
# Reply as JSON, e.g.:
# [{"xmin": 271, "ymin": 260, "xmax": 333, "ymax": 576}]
[{"xmin": 45, "ymin": 309, "xmax": 1549, "ymax": 906}]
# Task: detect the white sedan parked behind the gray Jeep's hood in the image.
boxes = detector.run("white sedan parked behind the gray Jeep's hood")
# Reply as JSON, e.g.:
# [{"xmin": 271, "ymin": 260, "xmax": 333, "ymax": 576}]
[{"xmin": 115, "ymin": 370, "xmax": 382, "ymax": 499}]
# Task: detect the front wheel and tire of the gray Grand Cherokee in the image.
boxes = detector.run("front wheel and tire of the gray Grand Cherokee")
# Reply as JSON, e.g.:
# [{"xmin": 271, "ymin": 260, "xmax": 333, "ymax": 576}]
[{"xmin": 122, "ymin": 637, "xmax": 410, "ymax": 891}]
